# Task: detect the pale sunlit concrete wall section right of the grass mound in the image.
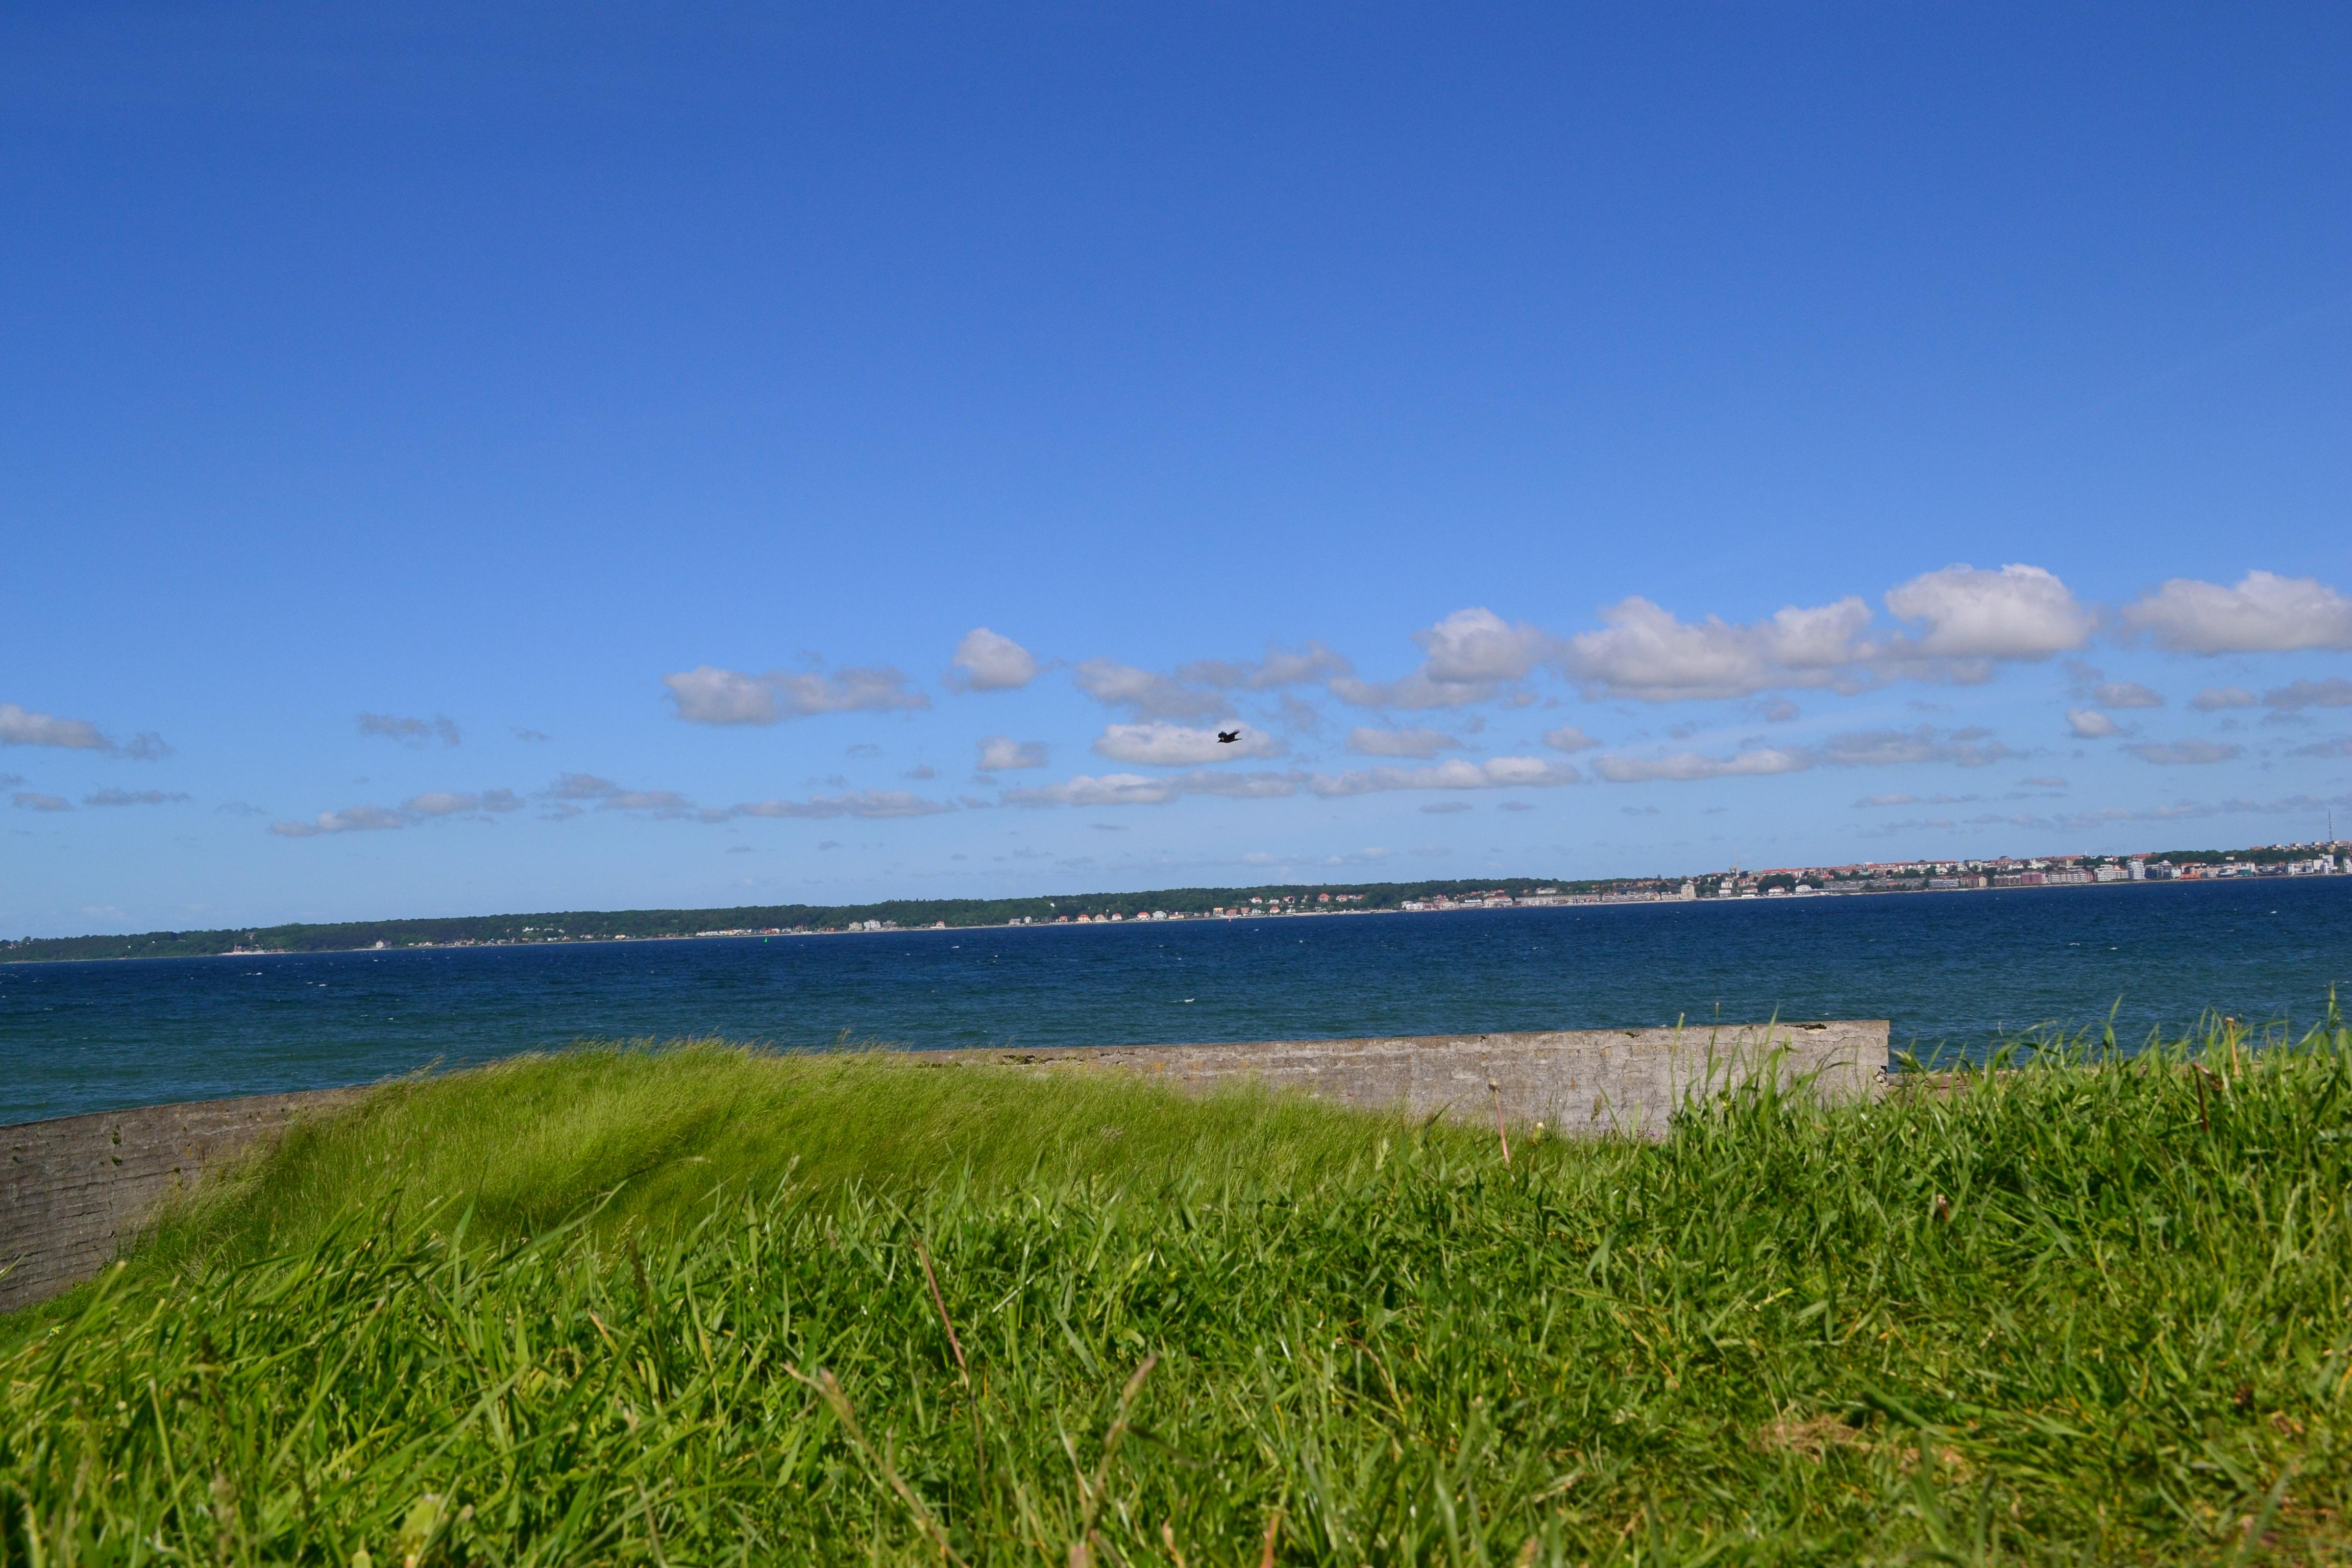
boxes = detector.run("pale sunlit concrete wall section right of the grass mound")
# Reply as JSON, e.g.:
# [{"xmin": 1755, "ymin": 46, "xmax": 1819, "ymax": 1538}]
[{"xmin": 922, "ymin": 1018, "xmax": 1889, "ymax": 1138}]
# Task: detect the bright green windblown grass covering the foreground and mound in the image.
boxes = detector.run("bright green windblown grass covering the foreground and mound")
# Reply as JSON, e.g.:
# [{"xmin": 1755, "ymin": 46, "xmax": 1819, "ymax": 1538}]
[{"xmin": 0, "ymin": 1020, "xmax": 2352, "ymax": 1568}]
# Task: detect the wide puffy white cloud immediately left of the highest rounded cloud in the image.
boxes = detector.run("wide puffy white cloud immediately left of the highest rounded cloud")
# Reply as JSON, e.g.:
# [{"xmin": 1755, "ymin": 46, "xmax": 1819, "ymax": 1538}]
[{"xmin": 1564, "ymin": 597, "xmax": 1870, "ymax": 703}]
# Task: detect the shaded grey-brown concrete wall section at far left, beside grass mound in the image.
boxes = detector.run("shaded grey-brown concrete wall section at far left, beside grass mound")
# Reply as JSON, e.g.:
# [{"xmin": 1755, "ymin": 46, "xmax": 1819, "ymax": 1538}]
[{"xmin": 0, "ymin": 1088, "xmax": 367, "ymax": 1312}]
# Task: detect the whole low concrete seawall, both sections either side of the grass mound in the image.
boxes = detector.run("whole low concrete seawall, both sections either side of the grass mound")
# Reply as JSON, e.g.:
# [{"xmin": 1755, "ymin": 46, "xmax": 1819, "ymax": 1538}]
[{"xmin": 0, "ymin": 1020, "xmax": 1886, "ymax": 1312}]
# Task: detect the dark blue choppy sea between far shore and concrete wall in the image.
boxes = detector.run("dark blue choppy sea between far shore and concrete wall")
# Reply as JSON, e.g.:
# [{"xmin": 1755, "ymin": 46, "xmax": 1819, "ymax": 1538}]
[{"xmin": 0, "ymin": 877, "xmax": 2352, "ymax": 1124}]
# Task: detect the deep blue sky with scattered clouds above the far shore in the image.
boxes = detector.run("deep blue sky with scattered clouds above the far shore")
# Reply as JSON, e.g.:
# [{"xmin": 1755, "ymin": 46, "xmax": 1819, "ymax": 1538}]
[{"xmin": 0, "ymin": 5, "xmax": 2352, "ymax": 936}]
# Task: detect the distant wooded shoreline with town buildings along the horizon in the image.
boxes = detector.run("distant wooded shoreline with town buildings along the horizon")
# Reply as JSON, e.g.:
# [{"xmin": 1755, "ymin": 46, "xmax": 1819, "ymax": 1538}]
[{"xmin": 0, "ymin": 844, "xmax": 2352, "ymax": 964}]
